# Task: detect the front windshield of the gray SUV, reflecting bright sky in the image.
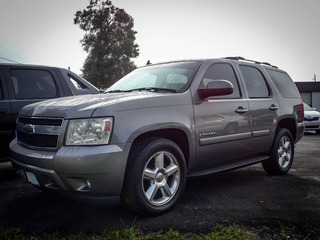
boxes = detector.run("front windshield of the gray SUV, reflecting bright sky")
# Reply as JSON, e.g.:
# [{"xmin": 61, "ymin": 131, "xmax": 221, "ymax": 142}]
[{"xmin": 106, "ymin": 61, "xmax": 200, "ymax": 93}]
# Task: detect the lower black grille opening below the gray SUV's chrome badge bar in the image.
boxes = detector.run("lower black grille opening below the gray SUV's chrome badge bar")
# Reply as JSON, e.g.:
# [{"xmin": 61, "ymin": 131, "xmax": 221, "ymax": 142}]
[{"xmin": 17, "ymin": 131, "xmax": 59, "ymax": 148}]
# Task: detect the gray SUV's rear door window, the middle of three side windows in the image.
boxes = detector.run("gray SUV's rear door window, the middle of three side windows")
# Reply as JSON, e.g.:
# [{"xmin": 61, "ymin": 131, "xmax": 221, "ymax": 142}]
[{"xmin": 240, "ymin": 66, "xmax": 270, "ymax": 98}]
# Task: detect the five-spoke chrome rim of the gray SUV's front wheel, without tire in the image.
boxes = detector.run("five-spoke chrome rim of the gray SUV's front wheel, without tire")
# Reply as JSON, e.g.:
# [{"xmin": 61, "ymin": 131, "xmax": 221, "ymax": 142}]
[{"xmin": 142, "ymin": 151, "xmax": 180, "ymax": 206}]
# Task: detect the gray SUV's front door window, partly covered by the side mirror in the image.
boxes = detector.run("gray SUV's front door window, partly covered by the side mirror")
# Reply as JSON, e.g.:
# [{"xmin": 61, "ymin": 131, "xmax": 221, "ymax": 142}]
[{"xmin": 200, "ymin": 63, "xmax": 241, "ymax": 99}]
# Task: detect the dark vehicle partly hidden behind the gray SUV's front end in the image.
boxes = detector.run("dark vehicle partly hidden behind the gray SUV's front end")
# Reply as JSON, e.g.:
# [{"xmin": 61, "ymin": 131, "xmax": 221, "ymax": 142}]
[{"xmin": 0, "ymin": 63, "xmax": 99, "ymax": 161}]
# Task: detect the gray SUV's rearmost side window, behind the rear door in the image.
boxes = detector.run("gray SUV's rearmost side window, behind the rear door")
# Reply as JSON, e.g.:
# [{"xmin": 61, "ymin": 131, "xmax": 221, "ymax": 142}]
[{"xmin": 267, "ymin": 69, "xmax": 300, "ymax": 98}]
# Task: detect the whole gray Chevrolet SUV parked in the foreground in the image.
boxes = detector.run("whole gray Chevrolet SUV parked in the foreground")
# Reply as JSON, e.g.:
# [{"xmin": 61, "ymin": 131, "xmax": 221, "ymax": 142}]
[{"xmin": 10, "ymin": 57, "xmax": 304, "ymax": 215}]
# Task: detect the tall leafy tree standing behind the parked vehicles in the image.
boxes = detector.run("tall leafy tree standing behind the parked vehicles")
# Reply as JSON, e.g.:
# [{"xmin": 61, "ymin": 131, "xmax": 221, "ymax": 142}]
[{"xmin": 74, "ymin": 0, "xmax": 139, "ymax": 89}]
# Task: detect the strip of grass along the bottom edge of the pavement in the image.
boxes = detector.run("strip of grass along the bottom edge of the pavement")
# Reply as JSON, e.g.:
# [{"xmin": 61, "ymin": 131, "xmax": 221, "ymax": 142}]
[{"xmin": 0, "ymin": 225, "xmax": 320, "ymax": 240}]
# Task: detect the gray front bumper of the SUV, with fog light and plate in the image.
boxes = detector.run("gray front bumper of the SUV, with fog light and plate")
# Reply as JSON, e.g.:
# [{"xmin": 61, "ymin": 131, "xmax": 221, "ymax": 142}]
[{"xmin": 10, "ymin": 140, "xmax": 129, "ymax": 199}]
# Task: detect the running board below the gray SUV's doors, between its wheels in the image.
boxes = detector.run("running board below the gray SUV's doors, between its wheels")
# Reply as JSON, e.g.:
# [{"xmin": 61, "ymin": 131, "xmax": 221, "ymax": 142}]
[{"xmin": 187, "ymin": 155, "xmax": 269, "ymax": 177}]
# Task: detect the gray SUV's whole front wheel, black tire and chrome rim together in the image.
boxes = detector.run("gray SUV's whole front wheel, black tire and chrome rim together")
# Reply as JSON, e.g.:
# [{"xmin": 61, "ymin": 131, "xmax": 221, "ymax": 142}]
[{"xmin": 121, "ymin": 138, "xmax": 186, "ymax": 216}]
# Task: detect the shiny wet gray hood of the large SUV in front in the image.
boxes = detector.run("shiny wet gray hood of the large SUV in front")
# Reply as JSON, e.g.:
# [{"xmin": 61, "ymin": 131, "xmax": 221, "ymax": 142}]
[{"xmin": 20, "ymin": 92, "xmax": 188, "ymax": 119}]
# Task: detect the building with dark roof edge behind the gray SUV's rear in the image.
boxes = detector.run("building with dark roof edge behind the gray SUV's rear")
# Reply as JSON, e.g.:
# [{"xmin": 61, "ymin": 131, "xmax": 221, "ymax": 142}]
[{"xmin": 295, "ymin": 82, "xmax": 320, "ymax": 111}]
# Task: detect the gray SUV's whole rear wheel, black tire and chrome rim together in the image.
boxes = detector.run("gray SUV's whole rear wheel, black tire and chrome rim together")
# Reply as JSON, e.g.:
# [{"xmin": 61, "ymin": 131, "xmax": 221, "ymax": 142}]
[{"xmin": 262, "ymin": 128, "xmax": 294, "ymax": 175}]
